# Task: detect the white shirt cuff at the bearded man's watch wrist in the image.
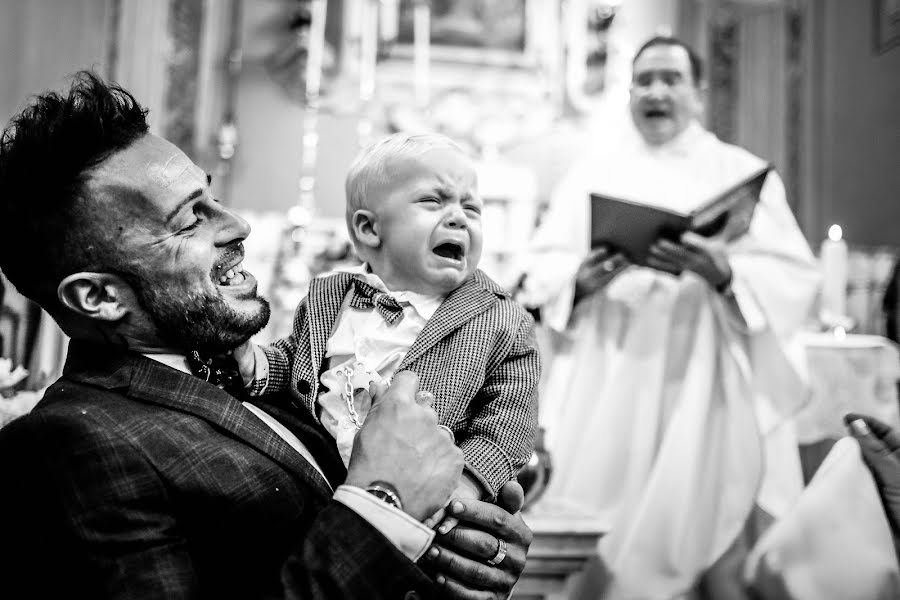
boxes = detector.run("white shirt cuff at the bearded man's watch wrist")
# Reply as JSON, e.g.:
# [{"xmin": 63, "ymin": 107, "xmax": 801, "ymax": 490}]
[{"xmin": 334, "ymin": 485, "xmax": 434, "ymax": 562}]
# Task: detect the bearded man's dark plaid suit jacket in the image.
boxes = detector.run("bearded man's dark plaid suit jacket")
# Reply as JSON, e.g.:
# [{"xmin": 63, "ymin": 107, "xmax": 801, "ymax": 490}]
[{"xmin": 0, "ymin": 342, "xmax": 437, "ymax": 600}]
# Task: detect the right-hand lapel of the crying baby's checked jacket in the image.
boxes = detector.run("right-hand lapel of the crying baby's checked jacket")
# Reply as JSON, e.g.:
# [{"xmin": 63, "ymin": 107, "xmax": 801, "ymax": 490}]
[{"xmin": 397, "ymin": 270, "xmax": 508, "ymax": 371}]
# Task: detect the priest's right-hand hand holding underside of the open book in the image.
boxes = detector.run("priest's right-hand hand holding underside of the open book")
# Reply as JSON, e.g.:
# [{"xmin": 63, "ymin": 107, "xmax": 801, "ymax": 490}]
[{"xmin": 647, "ymin": 231, "xmax": 731, "ymax": 289}]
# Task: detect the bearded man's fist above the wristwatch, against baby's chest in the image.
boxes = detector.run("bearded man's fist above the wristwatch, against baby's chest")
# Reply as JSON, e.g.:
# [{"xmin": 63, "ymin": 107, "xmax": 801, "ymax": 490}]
[{"xmin": 347, "ymin": 371, "xmax": 465, "ymax": 521}]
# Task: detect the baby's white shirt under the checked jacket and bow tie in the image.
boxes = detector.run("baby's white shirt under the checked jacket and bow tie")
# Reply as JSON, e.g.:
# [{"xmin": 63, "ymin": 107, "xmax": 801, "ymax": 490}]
[{"xmin": 316, "ymin": 265, "xmax": 444, "ymax": 465}]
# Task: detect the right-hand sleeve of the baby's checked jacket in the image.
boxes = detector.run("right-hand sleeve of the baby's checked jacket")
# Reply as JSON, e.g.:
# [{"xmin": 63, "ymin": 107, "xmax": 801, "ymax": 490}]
[{"xmin": 458, "ymin": 310, "xmax": 541, "ymax": 499}]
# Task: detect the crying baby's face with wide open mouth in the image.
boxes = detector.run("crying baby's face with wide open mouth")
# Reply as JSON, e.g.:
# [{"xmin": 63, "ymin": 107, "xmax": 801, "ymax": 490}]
[{"xmin": 368, "ymin": 148, "xmax": 482, "ymax": 294}]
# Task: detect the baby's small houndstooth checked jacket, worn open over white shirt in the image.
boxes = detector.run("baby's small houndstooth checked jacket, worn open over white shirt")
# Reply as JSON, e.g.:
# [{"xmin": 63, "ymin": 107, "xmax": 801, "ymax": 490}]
[{"xmin": 263, "ymin": 270, "xmax": 541, "ymax": 495}]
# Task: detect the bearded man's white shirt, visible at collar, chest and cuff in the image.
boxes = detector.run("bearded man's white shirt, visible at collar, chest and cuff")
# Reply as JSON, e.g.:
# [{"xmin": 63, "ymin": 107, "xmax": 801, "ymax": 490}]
[{"xmin": 144, "ymin": 354, "xmax": 434, "ymax": 562}]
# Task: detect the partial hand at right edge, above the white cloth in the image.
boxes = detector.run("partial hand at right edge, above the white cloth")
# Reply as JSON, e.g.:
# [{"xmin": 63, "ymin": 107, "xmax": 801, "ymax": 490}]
[{"xmin": 844, "ymin": 413, "xmax": 900, "ymax": 535}]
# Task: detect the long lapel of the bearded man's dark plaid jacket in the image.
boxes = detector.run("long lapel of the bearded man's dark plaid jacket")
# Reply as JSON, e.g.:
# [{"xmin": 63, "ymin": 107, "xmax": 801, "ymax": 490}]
[{"xmin": 64, "ymin": 341, "xmax": 330, "ymax": 495}]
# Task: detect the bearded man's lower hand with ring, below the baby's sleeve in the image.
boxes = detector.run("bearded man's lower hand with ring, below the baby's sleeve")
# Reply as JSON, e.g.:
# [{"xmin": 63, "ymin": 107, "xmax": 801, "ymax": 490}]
[{"xmin": 425, "ymin": 481, "xmax": 532, "ymax": 600}]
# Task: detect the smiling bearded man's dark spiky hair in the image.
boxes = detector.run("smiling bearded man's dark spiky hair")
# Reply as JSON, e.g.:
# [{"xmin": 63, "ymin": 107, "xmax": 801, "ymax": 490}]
[{"xmin": 0, "ymin": 71, "xmax": 148, "ymax": 308}]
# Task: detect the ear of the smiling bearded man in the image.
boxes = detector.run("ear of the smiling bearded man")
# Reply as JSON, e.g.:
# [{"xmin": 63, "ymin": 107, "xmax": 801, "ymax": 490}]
[{"xmin": 56, "ymin": 272, "xmax": 134, "ymax": 321}]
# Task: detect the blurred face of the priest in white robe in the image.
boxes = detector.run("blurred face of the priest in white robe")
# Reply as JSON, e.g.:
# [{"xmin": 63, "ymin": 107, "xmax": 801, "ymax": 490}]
[{"xmin": 631, "ymin": 45, "xmax": 700, "ymax": 146}]
